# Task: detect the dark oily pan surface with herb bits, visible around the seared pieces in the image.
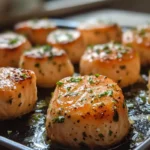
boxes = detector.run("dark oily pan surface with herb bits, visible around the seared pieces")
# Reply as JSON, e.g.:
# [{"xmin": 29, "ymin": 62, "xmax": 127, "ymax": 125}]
[{"xmin": 0, "ymin": 20, "xmax": 150, "ymax": 150}]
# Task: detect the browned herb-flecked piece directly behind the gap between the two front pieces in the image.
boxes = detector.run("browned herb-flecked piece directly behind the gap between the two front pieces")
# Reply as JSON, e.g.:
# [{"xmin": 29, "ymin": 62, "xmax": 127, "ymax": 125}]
[{"xmin": 20, "ymin": 45, "xmax": 74, "ymax": 87}]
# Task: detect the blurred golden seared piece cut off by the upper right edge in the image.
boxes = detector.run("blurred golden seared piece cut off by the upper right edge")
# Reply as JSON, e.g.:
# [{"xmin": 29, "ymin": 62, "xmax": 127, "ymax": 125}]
[{"xmin": 123, "ymin": 26, "xmax": 150, "ymax": 65}]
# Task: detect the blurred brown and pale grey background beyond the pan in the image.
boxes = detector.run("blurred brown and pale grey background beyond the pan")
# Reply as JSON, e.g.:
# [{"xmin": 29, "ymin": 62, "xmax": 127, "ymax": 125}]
[{"xmin": 0, "ymin": 0, "xmax": 150, "ymax": 27}]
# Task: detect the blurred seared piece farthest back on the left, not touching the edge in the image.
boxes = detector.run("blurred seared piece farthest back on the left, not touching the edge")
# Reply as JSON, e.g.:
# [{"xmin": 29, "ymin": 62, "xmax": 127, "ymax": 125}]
[{"xmin": 15, "ymin": 19, "xmax": 57, "ymax": 44}]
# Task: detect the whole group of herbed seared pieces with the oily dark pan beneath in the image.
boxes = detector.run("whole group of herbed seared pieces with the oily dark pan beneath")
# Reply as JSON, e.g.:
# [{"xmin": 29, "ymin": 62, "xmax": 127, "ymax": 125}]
[{"xmin": 0, "ymin": 19, "xmax": 150, "ymax": 150}]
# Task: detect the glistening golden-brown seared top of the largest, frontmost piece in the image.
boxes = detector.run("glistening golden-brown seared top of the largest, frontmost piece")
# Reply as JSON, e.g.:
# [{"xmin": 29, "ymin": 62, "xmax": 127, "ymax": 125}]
[{"xmin": 51, "ymin": 75, "xmax": 124, "ymax": 121}]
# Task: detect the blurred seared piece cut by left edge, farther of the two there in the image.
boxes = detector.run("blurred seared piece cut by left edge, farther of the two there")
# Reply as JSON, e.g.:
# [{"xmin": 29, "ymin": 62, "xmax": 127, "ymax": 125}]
[{"xmin": 0, "ymin": 32, "xmax": 31, "ymax": 67}]
